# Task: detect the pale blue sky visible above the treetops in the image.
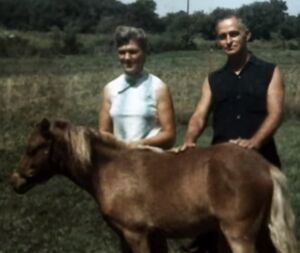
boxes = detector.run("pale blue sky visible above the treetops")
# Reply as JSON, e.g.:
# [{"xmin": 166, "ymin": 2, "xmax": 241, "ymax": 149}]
[{"xmin": 119, "ymin": 0, "xmax": 300, "ymax": 16}]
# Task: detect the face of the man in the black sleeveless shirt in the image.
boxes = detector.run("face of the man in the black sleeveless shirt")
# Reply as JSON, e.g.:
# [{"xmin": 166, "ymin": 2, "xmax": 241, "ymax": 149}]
[{"xmin": 217, "ymin": 17, "xmax": 250, "ymax": 56}]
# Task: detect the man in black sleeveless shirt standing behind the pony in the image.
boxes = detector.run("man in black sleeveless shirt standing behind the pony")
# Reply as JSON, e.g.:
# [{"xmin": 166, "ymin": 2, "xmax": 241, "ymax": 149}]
[{"xmin": 180, "ymin": 15, "xmax": 284, "ymax": 253}]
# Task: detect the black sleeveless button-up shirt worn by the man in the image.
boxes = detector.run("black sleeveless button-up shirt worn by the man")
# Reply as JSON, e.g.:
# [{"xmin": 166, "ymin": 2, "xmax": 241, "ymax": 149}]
[{"xmin": 209, "ymin": 55, "xmax": 280, "ymax": 167}]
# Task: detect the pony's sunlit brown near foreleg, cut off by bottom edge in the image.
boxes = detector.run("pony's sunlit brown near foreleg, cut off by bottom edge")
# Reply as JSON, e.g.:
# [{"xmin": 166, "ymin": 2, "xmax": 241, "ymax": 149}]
[{"xmin": 123, "ymin": 230, "xmax": 151, "ymax": 253}]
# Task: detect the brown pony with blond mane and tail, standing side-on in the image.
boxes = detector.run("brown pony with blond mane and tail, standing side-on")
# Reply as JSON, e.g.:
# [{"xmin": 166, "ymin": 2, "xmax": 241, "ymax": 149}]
[{"xmin": 11, "ymin": 119, "xmax": 297, "ymax": 253}]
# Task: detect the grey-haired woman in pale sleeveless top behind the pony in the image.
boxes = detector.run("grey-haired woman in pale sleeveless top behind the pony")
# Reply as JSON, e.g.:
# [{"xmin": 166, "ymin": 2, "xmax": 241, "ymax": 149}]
[{"xmin": 99, "ymin": 26, "xmax": 176, "ymax": 148}]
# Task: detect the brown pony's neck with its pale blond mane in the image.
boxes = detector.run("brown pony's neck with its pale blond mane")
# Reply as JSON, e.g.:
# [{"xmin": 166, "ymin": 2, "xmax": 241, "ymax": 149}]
[{"xmin": 52, "ymin": 127, "xmax": 127, "ymax": 192}]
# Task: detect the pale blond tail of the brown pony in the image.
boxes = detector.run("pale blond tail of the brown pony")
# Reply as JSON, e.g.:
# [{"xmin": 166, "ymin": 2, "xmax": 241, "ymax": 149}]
[{"xmin": 269, "ymin": 167, "xmax": 297, "ymax": 253}]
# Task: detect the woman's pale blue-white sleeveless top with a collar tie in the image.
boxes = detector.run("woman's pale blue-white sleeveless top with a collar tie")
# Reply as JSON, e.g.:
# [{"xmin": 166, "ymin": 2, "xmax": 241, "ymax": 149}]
[{"xmin": 106, "ymin": 72, "xmax": 164, "ymax": 141}]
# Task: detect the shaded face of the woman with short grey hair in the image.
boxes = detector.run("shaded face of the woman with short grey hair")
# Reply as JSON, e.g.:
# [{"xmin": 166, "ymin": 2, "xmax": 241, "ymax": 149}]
[{"xmin": 118, "ymin": 40, "xmax": 145, "ymax": 75}]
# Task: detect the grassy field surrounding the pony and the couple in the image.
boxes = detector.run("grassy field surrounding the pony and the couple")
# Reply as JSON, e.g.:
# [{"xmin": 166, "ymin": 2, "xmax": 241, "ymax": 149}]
[{"xmin": 0, "ymin": 48, "xmax": 300, "ymax": 253}]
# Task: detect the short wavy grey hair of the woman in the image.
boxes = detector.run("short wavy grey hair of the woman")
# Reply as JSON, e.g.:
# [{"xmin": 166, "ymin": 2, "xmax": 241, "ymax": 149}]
[{"xmin": 115, "ymin": 26, "xmax": 147, "ymax": 52}]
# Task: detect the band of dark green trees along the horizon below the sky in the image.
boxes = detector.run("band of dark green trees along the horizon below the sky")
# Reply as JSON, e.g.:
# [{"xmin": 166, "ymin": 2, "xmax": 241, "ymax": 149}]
[{"xmin": 0, "ymin": 0, "xmax": 300, "ymax": 43}]
